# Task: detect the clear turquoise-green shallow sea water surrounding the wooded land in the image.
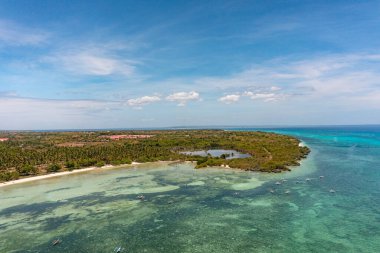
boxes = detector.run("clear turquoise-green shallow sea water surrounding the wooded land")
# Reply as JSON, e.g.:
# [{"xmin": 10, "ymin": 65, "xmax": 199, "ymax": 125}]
[{"xmin": 0, "ymin": 127, "xmax": 380, "ymax": 252}]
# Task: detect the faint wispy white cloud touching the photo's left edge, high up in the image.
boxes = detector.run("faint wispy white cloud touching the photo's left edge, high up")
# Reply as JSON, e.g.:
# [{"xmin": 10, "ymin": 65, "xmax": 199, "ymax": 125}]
[{"xmin": 0, "ymin": 20, "xmax": 48, "ymax": 46}]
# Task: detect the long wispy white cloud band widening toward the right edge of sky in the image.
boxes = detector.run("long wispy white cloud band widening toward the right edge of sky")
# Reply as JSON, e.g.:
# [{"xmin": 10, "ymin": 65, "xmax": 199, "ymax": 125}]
[{"xmin": 168, "ymin": 54, "xmax": 380, "ymax": 93}]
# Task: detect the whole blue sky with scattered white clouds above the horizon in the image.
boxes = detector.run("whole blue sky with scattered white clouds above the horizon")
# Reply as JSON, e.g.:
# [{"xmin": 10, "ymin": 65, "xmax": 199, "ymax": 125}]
[{"xmin": 0, "ymin": 0, "xmax": 380, "ymax": 130}]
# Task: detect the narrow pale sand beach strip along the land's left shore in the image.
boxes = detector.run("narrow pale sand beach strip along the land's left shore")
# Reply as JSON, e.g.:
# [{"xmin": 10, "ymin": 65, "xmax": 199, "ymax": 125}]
[{"xmin": 0, "ymin": 161, "xmax": 176, "ymax": 188}]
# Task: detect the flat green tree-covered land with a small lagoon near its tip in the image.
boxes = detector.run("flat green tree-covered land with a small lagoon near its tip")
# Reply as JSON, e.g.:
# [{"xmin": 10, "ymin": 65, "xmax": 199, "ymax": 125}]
[{"xmin": 0, "ymin": 130, "xmax": 310, "ymax": 181}]
